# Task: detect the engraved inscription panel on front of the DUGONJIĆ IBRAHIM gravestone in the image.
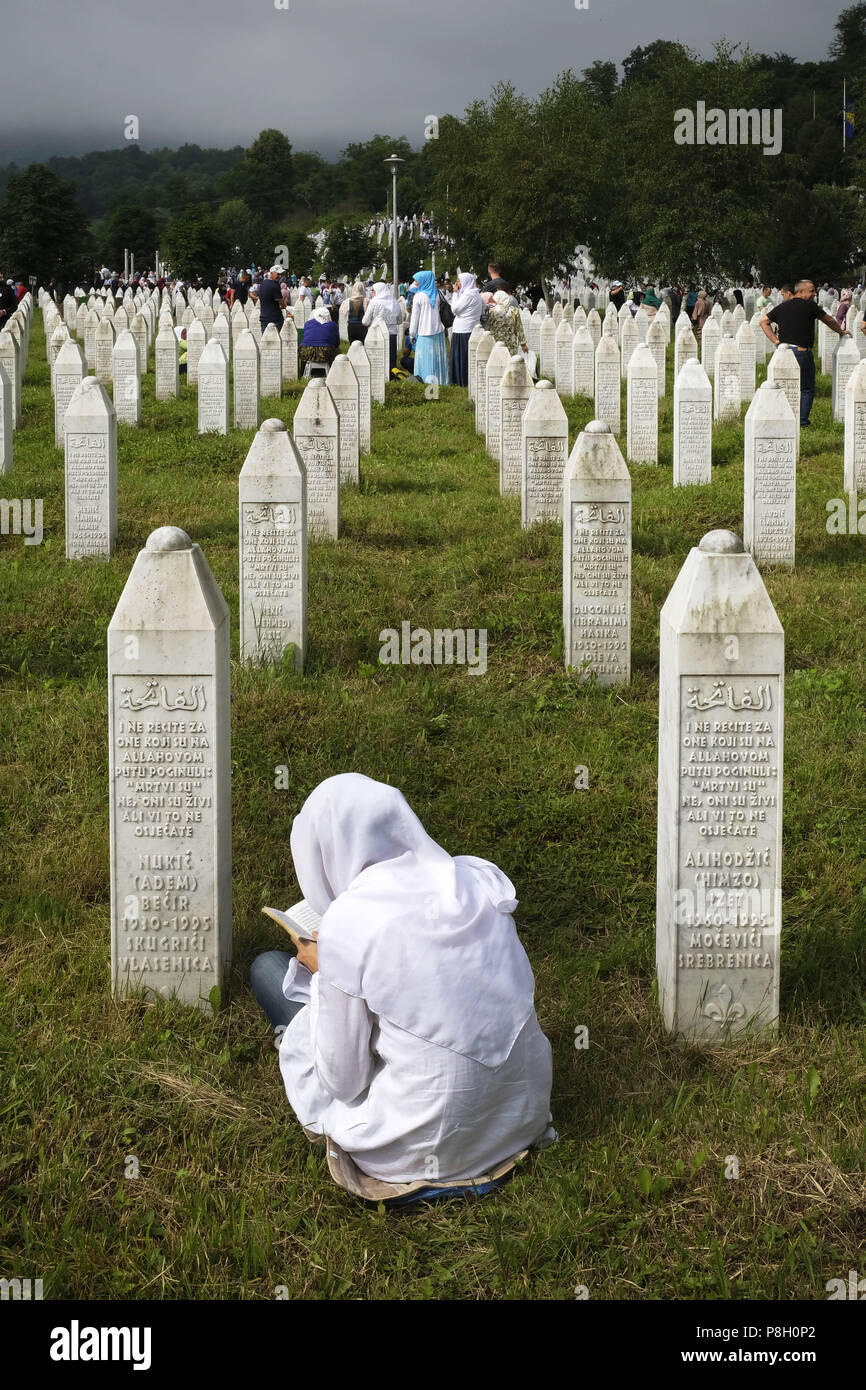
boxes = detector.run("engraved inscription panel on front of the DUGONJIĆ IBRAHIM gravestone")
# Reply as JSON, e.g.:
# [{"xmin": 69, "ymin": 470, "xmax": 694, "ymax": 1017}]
[{"xmin": 571, "ymin": 502, "xmax": 631, "ymax": 680}]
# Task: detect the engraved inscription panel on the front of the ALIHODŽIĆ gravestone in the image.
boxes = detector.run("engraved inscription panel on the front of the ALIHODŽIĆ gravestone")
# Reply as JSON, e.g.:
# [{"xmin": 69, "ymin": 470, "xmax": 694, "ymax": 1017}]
[{"xmin": 677, "ymin": 676, "xmax": 781, "ymax": 970}]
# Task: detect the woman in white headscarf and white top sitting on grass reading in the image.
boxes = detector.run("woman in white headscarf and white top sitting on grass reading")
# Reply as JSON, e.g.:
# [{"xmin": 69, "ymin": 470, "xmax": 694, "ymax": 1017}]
[{"xmin": 252, "ymin": 773, "xmax": 553, "ymax": 1200}]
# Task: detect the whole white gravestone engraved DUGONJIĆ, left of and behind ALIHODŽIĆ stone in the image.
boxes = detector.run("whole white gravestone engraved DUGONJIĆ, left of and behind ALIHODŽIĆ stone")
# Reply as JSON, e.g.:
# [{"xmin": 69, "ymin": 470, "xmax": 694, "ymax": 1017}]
[{"xmin": 563, "ymin": 420, "xmax": 631, "ymax": 685}]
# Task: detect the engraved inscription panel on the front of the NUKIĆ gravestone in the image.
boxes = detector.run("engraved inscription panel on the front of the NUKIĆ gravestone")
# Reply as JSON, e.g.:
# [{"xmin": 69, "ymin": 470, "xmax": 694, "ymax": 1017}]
[{"xmin": 111, "ymin": 674, "xmax": 217, "ymax": 977}]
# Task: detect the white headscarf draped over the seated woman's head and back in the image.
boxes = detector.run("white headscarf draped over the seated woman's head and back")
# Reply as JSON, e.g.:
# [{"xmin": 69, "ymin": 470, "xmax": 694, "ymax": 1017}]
[{"xmin": 292, "ymin": 773, "xmax": 534, "ymax": 1068}]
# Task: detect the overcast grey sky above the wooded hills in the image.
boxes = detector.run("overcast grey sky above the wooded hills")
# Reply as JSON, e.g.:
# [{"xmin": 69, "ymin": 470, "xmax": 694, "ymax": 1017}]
[{"xmin": 0, "ymin": 0, "xmax": 839, "ymax": 163}]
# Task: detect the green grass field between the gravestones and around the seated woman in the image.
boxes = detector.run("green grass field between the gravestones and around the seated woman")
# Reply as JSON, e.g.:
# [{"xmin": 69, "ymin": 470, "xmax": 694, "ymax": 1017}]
[{"xmin": 0, "ymin": 314, "xmax": 866, "ymax": 1300}]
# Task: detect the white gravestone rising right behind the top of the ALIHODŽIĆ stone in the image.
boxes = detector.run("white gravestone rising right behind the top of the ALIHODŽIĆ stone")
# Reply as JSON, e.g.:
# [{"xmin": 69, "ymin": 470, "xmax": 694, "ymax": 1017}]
[{"xmin": 742, "ymin": 381, "xmax": 796, "ymax": 569}]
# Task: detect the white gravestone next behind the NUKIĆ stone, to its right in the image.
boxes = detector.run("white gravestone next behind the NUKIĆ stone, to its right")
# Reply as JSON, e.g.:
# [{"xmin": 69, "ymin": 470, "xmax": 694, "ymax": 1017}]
[{"xmin": 238, "ymin": 420, "xmax": 307, "ymax": 671}]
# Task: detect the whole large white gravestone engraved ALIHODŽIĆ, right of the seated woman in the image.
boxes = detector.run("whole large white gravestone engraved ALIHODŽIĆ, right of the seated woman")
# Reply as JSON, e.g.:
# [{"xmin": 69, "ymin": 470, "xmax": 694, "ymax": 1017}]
[{"xmin": 656, "ymin": 530, "xmax": 784, "ymax": 1047}]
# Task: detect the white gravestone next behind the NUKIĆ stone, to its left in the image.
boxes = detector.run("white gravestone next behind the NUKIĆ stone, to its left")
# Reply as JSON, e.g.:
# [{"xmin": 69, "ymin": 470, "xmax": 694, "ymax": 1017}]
[{"xmin": 63, "ymin": 377, "xmax": 117, "ymax": 560}]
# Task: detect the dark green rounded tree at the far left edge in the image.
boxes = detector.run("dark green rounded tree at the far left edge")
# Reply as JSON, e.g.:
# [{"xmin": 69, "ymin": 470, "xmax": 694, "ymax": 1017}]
[{"xmin": 0, "ymin": 164, "xmax": 93, "ymax": 281}]
